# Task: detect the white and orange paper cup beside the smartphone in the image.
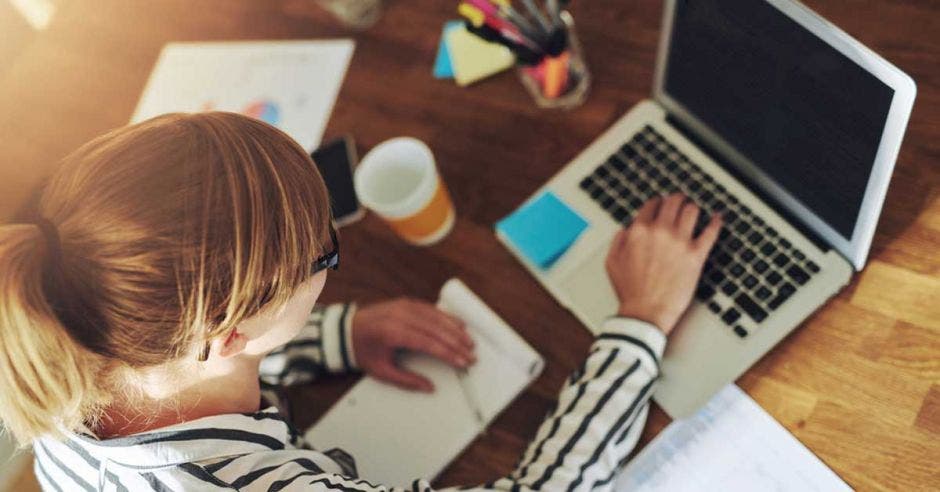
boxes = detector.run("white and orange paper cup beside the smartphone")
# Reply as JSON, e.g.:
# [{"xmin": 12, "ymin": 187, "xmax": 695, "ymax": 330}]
[{"xmin": 355, "ymin": 137, "xmax": 456, "ymax": 246}]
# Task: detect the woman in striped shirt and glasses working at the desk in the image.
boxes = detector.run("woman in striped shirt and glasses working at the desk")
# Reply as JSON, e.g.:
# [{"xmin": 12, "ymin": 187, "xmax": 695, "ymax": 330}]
[{"xmin": 0, "ymin": 113, "xmax": 719, "ymax": 490}]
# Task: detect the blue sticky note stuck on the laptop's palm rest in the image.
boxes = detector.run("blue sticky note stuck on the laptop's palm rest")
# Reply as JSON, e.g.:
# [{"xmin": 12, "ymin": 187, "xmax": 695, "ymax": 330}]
[{"xmin": 496, "ymin": 191, "xmax": 588, "ymax": 269}]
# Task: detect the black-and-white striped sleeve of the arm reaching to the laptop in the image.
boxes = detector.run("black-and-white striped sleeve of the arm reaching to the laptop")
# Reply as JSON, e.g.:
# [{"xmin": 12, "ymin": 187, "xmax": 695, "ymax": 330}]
[{"xmin": 492, "ymin": 318, "xmax": 666, "ymax": 490}]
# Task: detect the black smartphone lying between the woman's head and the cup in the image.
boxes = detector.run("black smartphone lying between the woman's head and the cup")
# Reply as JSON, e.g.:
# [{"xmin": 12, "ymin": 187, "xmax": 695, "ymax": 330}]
[{"xmin": 310, "ymin": 135, "xmax": 365, "ymax": 226}]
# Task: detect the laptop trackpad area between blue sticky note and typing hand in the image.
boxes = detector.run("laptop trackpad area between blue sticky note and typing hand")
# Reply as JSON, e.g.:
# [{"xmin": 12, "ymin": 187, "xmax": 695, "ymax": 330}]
[{"xmin": 561, "ymin": 241, "xmax": 617, "ymax": 333}]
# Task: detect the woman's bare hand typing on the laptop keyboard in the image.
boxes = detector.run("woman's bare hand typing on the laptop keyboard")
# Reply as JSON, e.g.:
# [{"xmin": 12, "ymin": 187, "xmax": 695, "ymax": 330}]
[{"xmin": 606, "ymin": 193, "xmax": 721, "ymax": 335}]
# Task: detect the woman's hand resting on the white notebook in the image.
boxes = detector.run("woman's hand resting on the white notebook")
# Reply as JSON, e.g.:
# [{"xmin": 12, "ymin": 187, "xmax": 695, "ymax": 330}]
[{"xmin": 352, "ymin": 298, "xmax": 476, "ymax": 392}]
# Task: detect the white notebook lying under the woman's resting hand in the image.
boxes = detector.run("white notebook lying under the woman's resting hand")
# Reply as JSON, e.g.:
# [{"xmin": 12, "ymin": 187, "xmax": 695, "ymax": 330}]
[{"xmin": 304, "ymin": 279, "xmax": 545, "ymax": 486}]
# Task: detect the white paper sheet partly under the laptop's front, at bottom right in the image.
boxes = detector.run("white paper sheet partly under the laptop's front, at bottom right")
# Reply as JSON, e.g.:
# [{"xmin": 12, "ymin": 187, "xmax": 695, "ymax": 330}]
[{"xmin": 614, "ymin": 384, "xmax": 852, "ymax": 492}]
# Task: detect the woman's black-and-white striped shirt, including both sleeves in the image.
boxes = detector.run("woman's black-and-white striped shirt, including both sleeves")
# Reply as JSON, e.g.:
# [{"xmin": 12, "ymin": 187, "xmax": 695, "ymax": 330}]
[{"xmin": 33, "ymin": 304, "xmax": 666, "ymax": 492}]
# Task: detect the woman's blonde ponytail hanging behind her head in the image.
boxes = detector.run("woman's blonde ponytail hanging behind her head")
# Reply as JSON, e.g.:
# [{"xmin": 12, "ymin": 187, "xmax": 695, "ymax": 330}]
[{"xmin": 0, "ymin": 225, "xmax": 102, "ymax": 446}]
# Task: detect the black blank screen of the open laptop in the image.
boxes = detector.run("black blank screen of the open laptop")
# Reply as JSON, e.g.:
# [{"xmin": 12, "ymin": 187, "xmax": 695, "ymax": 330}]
[{"xmin": 664, "ymin": 0, "xmax": 894, "ymax": 238}]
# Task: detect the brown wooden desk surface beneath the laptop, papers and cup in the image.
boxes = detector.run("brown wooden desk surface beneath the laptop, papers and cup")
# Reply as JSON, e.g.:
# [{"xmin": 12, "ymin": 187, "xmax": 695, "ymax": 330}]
[{"xmin": 0, "ymin": 0, "xmax": 940, "ymax": 491}]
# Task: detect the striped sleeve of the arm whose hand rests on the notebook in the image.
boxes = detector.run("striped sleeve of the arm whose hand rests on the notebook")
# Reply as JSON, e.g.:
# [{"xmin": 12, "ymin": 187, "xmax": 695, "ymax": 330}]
[{"xmin": 260, "ymin": 304, "xmax": 359, "ymax": 386}]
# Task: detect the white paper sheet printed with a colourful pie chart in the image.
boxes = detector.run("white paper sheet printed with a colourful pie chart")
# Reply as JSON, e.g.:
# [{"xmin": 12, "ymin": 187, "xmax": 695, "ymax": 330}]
[{"xmin": 131, "ymin": 39, "xmax": 355, "ymax": 151}]
